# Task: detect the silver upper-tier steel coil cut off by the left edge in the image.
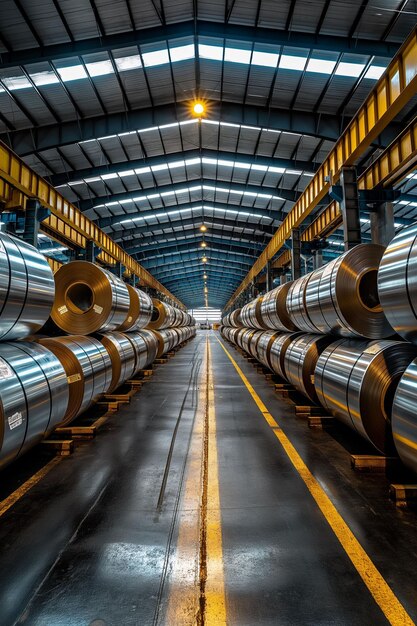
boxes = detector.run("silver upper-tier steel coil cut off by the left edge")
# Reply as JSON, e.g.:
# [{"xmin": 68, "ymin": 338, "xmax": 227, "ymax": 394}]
[{"xmin": 0, "ymin": 233, "xmax": 55, "ymax": 341}]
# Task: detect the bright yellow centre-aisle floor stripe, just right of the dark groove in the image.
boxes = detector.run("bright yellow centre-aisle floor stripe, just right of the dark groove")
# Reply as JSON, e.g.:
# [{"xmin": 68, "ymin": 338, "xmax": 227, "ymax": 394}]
[{"xmin": 204, "ymin": 344, "xmax": 227, "ymax": 626}]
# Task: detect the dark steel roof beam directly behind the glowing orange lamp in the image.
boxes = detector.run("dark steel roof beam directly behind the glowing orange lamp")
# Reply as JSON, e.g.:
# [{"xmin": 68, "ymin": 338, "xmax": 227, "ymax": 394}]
[{"xmin": 0, "ymin": 100, "xmax": 401, "ymax": 156}]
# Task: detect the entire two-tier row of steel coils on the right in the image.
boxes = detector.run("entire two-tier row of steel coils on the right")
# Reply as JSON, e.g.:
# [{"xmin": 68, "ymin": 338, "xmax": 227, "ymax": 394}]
[{"xmin": 222, "ymin": 225, "xmax": 417, "ymax": 472}]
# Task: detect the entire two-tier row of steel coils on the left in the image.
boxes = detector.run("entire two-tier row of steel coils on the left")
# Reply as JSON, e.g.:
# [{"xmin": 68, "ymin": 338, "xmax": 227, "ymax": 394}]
[{"xmin": 0, "ymin": 233, "xmax": 195, "ymax": 467}]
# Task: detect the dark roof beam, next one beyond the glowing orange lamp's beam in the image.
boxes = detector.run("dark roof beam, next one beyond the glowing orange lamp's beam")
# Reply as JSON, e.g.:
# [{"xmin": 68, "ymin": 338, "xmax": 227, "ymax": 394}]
[{"xmin": 46, "ymin": 150, "xmax": 319, "ymax": 187}]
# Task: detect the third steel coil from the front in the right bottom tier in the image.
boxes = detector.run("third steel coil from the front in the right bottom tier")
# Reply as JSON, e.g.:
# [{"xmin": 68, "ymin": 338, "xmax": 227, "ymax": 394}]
[{"xmin": 284, "ymin": 334, "xmax": 334, "ymax": 402}]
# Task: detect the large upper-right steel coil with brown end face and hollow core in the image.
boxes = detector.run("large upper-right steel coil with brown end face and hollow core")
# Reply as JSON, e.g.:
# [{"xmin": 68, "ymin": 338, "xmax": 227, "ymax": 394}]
[{"xmin": 287, "ymin": 244, "xmax": 393, "ymax": 339}]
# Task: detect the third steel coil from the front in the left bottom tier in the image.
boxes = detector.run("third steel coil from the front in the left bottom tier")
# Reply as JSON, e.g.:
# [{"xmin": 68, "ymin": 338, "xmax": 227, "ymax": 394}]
[{"xmin": 95, "ymin": 331, "xmax": 136, "ymax": 393}]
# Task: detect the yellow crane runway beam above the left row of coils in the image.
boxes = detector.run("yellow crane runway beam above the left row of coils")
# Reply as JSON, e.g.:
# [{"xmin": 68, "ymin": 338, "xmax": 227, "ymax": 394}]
[{"xmin": 0, "ymin": 142, "xmax": 185, "ymax": 308}]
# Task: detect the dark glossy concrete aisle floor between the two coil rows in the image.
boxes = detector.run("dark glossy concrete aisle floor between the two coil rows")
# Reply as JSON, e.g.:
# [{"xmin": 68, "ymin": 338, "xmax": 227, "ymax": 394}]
[{"xmin": 0, "ymin": 332, "xmax": 417, "ymax": 626}]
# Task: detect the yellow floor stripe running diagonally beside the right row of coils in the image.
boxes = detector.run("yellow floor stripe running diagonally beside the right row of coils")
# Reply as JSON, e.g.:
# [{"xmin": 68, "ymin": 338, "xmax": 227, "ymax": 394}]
[{"xmin": 216, "ymin": 338, "xmax": 415, "ymax": 626}]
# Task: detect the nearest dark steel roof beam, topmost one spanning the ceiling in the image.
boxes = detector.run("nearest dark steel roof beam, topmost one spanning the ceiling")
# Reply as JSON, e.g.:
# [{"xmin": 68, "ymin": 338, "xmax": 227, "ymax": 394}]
[{"xmin": 2, "ymin": 20, "xmax": 398, "ymax": 68}]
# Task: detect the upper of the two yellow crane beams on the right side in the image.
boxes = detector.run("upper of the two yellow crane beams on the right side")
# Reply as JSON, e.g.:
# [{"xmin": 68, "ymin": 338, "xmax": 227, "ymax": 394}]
[{"xmin": 225, "ymin": 27, "xmax": 417, "ymax": 309}]
